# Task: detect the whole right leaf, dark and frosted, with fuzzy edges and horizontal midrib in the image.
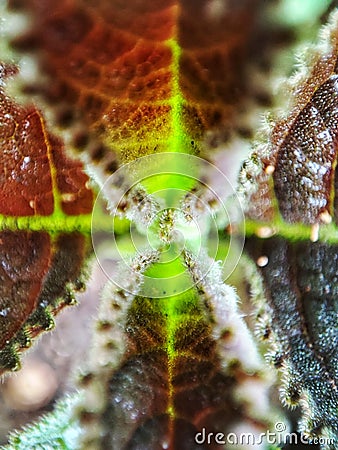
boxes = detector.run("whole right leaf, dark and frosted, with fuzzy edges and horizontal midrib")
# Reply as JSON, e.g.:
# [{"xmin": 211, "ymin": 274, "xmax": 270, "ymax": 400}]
[{"xmin": 241, "ymin": 11, "xmax": 338, "ymax": 442}]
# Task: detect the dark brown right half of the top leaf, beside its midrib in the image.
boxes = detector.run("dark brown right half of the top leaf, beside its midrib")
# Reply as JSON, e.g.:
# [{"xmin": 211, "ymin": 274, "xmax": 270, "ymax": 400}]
[{"xmin": 178, "ymin": 0, "xmax": 259, "ymax": 128}]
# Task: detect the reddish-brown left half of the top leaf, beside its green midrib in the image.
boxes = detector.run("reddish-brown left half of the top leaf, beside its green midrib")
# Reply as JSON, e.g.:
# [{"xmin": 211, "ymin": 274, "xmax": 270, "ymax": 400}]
[{"xmin": 8, "ymin": 0, "xmax": 175, "ymax": 160}]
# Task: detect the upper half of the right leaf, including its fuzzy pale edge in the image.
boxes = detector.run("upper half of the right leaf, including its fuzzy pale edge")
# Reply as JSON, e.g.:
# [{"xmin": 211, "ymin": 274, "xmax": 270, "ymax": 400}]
[{"xmin": 242, "ymin": 11, "xmax": 338, "ymax": 224}]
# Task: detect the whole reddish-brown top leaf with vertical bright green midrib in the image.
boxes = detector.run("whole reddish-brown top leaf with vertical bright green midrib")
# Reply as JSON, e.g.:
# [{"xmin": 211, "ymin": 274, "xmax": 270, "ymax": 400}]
[{"xmin": 10, "ymin": 0, "xmax": 260, "ymax": 165}]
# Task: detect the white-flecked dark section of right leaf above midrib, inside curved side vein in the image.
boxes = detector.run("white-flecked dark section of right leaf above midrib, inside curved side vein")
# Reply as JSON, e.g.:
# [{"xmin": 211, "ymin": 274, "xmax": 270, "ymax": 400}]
[{"xmin": 273, "ymin": 74, "xmax": 338, "ymax": 227}]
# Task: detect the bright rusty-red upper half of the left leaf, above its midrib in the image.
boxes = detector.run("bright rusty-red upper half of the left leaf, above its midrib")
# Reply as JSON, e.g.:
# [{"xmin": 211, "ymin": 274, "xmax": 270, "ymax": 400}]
[{"xmin": 0, "ymin": 63, "xmax": 93, "ymax": 216}]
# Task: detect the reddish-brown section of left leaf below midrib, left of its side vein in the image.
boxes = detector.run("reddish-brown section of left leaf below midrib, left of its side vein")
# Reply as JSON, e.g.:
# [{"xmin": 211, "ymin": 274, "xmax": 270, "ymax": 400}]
[{"xmin": 0, "ymin": 231, "xmax": 51, "ymax": 350}]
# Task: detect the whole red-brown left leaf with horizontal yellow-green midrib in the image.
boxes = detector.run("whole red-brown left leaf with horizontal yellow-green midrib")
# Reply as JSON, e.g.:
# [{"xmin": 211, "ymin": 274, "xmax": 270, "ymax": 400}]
[{"xmin": 0, "ymin": 65, "xmax": 93, "ymax": 373}]
